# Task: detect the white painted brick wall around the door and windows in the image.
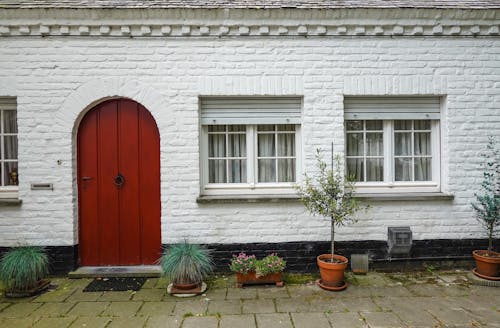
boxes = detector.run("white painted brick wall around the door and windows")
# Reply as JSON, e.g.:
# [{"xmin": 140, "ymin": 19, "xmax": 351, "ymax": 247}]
[{"xmin": 0, "ymin": 26, "xmax": 500, "ymax": 246}]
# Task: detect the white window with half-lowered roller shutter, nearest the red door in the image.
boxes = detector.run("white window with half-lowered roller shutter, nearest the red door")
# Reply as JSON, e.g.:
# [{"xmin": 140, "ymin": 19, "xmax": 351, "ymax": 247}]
[{"xmin": 201, "ymin": 98, "xmax": 301, "ymax": 195}]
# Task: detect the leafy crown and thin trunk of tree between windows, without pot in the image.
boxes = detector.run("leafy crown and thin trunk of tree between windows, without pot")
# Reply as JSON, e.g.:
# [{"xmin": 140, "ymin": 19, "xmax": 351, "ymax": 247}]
[{"xmin": 296, "ymin": 149, "xmax": 368, "ymax": 257}]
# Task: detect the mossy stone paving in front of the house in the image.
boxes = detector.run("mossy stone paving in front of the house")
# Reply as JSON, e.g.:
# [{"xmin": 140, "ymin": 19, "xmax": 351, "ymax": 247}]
[{"xmin": 0, "ymin": 271, "xmax": 500, "ymax": 328}]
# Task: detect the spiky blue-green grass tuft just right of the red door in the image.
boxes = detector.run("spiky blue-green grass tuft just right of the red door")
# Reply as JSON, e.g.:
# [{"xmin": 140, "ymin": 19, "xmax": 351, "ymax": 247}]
[{"xmin": 160, "ymin": 241, "xmax": 213, "ymax": 284}]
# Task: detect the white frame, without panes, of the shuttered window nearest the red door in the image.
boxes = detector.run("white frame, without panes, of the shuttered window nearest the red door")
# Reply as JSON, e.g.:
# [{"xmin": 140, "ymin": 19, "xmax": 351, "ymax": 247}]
[{"xmin": 200, "ymin": 123, "xmax": 302, "ymax": 196}]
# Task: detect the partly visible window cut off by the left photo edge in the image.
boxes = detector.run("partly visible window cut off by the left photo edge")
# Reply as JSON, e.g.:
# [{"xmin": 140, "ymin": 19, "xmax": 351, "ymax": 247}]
[{"xmin": 0, "ymin": 97, "xmax": 19, "ymax": 197}]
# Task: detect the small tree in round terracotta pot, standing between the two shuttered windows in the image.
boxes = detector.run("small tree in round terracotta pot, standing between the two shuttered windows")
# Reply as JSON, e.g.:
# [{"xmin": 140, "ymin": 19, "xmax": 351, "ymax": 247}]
[{"xmin": 296, "ymin": 145, "xmax": 367, "ymax": 291}]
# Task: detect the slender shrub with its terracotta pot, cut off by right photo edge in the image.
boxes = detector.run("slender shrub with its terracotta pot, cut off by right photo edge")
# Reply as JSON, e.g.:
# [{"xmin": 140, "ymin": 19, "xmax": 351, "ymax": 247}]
[{"xmin": 472, "ymin": 137, "xmax": 500, "ymax": 280}]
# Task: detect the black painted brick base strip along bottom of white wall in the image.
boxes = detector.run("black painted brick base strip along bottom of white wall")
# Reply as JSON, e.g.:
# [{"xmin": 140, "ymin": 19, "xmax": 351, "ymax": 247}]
[{"xmin": 0, "ymin": 239, "xmax": 500, "ymax": 275}]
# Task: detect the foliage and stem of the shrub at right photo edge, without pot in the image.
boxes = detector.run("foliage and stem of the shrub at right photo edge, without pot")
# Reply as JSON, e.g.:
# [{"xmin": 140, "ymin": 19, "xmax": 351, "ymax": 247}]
[{"xmin": 471, "ymin": 137, "xmax": 500, "ymax": 251}]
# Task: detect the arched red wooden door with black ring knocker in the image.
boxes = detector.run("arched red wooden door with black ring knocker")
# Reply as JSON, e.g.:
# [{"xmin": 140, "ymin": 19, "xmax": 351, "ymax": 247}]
[{"xmin": 78, "ymin": 99, "xmax": 161, "ymax": 266}]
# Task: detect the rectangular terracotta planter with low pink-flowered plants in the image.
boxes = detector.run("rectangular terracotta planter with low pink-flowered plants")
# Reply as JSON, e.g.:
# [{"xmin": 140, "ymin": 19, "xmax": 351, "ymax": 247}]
[{"xmin": 229, "ymin": 253, "xmax": 286, "ymax": 288}]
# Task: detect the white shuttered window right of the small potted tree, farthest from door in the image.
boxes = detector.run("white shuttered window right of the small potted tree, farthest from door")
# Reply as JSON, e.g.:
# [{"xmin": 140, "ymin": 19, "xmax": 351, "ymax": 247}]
[{"xmin": 345, "ymin": 97, "xmax": 440, "ymax": 192}]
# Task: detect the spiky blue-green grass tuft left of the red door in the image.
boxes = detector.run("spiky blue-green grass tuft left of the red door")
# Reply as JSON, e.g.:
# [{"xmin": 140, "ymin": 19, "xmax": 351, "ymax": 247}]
[{"xmin": 0, "ymin": 246, "xmax": 49, "ymax": 291}]
